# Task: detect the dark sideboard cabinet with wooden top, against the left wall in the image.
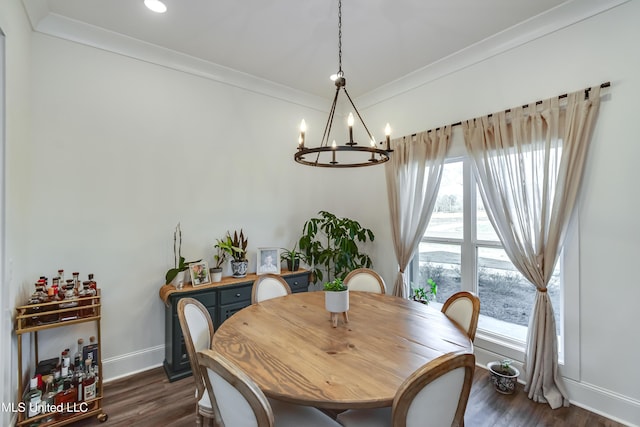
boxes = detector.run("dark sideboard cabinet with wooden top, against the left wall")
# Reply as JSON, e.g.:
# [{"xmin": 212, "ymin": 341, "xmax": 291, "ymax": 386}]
[{"xmin": 160, "ymin": 270, "xmax": 309, "ymax": 381}]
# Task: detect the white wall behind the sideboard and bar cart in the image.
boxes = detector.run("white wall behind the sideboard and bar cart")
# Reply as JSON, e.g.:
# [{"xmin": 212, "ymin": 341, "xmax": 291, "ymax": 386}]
[{"xmin": 23, "ymin": 33, "xmax": 386, "ymax": 379}]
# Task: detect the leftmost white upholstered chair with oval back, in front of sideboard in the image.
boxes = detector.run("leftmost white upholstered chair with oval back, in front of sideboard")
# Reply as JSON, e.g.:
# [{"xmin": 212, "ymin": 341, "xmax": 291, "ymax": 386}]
[{"xmin": 178, "ymin": 298, "xmax": 215, "ymax": 426}]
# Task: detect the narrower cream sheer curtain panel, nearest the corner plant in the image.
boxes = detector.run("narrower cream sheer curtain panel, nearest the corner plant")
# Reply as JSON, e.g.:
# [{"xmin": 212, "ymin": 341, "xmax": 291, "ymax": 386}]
[{"xmin": 385, "ymin": 126, "xmax": 451, "ymax": 298}]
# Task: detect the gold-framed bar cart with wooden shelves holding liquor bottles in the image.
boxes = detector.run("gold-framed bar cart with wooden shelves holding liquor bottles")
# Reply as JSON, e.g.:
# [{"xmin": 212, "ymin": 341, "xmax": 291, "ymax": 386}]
[{"xmin": 15, "ymin": 289, "xmax": 108, "ymax": 427}]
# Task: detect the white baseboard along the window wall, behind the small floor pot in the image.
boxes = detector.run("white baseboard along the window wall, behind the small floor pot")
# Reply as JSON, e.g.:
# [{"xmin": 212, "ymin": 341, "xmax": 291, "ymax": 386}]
[{"xmin": 474, "ymin": 346, "xmax": 640, "ymax": 427}]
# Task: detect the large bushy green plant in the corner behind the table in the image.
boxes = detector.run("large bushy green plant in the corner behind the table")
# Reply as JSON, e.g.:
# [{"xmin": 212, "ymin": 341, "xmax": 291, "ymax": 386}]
[{"xmin": 298, "ymin": 211, "xmax": 374, "ymax": 283}]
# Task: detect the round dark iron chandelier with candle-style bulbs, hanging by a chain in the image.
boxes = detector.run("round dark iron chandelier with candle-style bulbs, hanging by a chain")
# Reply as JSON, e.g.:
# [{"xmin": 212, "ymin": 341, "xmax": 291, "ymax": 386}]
[{"xmin": 293, "ymin": 0, "xmax": 393, "ymax": 168}]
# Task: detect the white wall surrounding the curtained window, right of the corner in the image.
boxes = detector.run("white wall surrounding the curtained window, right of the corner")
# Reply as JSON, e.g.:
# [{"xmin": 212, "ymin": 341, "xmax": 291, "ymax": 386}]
[{"xmin": 366, "ymin": 1, "xmax": 640, "ymax": 425}]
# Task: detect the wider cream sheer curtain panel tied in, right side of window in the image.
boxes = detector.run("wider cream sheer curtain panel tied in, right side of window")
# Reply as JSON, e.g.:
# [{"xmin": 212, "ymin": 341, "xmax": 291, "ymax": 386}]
[{"xmin": 462, "ymin": 87, "xmax": 600, "ymax": 409}]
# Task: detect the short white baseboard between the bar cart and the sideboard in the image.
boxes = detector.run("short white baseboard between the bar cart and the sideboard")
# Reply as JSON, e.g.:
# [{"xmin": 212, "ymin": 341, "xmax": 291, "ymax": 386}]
[{"xmin": 102, "ymin": 344, "xmax": 164, "ymax": 383}]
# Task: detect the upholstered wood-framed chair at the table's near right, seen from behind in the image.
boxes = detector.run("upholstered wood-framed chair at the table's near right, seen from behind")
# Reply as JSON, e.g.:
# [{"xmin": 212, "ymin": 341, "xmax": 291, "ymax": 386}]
[{"xmin": 338, "ymin": 353, "xmax": 475, "ymax": 427}]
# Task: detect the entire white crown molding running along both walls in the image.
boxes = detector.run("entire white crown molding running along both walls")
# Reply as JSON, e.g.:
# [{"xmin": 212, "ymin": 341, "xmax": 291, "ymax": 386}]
[{"xmin": 22, "ymin": 0, "xmax": 630, "ymax": 112}]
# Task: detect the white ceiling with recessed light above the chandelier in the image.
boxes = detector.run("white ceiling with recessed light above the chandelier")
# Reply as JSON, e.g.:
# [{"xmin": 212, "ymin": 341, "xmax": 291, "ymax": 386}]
[{"xmin": 23, "ymin": 0, "xmax": 610, "ymax": 98}]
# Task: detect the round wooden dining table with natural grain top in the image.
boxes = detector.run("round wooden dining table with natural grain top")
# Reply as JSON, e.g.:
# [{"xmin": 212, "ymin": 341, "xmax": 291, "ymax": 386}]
[{"xmin": 212, "ymin": 291, "xmax": 473, "ymax": 409}]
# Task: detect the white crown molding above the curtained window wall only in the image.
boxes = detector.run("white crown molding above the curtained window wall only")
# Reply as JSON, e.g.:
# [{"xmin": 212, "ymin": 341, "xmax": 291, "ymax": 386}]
[{"xmin": 357, "ymin": 0, "xmax": 630, "ymax": 109}]
